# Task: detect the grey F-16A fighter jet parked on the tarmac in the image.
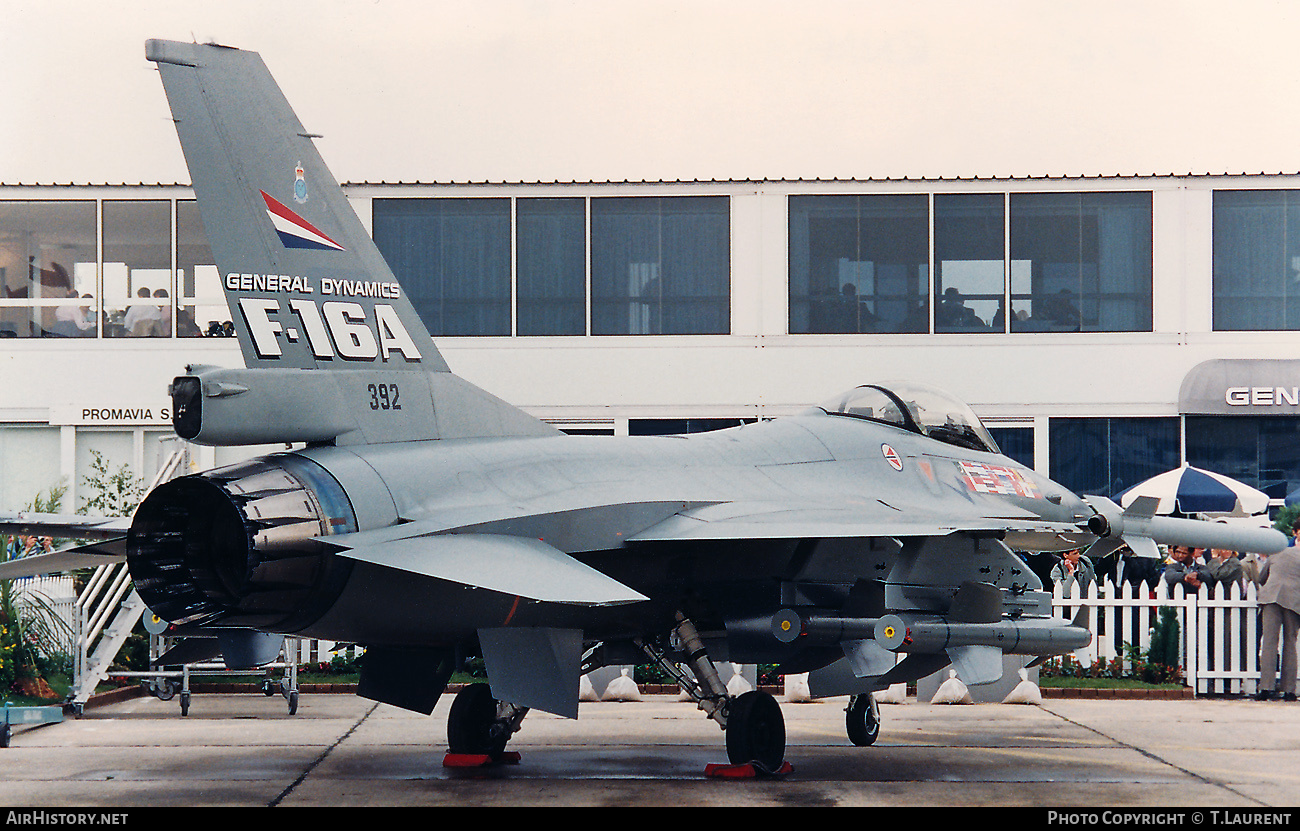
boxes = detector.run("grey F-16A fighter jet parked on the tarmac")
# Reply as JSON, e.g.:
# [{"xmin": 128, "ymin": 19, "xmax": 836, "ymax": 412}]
[{"xmin": 0, "ymin": 40, "xmax": 1286, "ymax": 771}]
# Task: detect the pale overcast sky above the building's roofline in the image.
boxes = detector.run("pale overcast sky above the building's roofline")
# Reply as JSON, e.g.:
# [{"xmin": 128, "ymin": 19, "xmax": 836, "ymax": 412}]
[{"xmin": 0, "ymin": 0, "xmax": 1300, "ymax": 183}]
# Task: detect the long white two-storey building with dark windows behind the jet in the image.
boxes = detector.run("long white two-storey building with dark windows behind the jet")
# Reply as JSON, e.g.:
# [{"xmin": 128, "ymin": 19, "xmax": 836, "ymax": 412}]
[{"xmin": 0, "ymin": 176, "xmax": 1300, "ymax": 508}]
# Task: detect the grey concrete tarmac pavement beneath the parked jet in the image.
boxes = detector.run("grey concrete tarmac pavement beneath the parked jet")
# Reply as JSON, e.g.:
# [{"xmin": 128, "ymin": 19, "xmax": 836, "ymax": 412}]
[{"xmin": 0, "ymin": 693, "xmax": 1300, "ymax": 811}]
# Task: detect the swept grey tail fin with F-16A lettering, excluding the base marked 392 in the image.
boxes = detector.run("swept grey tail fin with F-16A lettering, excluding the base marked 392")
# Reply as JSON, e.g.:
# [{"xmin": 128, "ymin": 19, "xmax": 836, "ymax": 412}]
[{"xmin": 146, "ymin": 40, "xmax": 447, "ymax": 372}]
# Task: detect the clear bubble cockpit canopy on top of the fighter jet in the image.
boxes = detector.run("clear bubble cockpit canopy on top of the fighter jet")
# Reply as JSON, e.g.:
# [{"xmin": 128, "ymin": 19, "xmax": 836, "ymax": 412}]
[{"xmin": 820, "ymin": 382, "xmax": 1001, "ymax": 453}]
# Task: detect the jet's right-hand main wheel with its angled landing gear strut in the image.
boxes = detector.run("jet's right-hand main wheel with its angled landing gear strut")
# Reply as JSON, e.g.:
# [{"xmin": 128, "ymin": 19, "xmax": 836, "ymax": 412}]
[{"xmin": 641, "ymin": 613, "xmax": 790, "ymax": 775}]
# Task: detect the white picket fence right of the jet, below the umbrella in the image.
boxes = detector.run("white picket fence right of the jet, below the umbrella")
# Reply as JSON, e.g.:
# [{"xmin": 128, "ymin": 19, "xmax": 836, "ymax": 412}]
[{"xmin": 1052, "ymin": 580, "xmax": 1289, "ymax": 694}]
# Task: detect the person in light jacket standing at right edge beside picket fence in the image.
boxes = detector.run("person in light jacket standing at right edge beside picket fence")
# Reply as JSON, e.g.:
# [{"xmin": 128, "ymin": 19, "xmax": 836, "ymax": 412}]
[{"xmin": 1255, "ymin": 533, "xmax": 1300, "ymax": 701}]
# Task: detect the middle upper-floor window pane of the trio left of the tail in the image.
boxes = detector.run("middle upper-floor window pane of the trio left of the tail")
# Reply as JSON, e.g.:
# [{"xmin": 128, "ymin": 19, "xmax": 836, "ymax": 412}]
[{"xmin": 101, "ymin": 200, "xmax": 172, "ymax": 338}]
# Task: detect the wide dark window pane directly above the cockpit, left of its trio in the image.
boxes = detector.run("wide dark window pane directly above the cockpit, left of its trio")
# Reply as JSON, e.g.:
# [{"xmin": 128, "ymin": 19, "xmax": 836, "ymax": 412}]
[{"xmin": 789, "ymin": 194, "xmax": 930, "ymax": 334}]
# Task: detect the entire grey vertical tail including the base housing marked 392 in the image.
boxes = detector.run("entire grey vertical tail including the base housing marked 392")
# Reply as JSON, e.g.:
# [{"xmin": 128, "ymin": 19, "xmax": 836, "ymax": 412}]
[{"xmin": 144, "ymin": 40, "xmax": 558, "ymax": 445}]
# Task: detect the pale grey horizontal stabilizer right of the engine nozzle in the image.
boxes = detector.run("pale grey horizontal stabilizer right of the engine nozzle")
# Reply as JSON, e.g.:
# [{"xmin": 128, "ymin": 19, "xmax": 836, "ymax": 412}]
[{"xmin": 337, "ymin": 534, "xmax": 647, "ymax": 606}]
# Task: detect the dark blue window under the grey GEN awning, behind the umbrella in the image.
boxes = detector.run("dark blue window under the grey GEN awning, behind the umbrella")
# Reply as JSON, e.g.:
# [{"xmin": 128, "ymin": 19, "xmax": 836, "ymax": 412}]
[{"xmin": 1187, "ymin": 416, "xmax": 1300, "ymax": 499}]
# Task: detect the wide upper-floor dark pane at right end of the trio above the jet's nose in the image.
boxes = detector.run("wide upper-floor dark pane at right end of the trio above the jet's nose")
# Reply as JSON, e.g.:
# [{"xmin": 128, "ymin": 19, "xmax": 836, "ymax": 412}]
[{"xmin": 1010, "ymin": 192, "xmax": 1152, "ymax": 332}]
